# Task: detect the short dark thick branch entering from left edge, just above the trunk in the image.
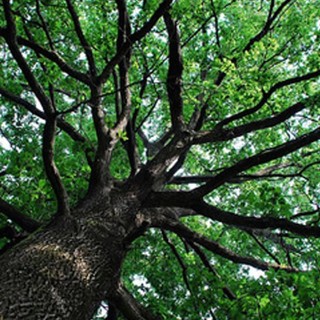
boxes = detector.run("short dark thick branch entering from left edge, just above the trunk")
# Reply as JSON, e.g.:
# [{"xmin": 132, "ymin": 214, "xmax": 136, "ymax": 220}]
[{"xmin": 0, "ymin": 199, "xmax": 41, "ymax": 232}]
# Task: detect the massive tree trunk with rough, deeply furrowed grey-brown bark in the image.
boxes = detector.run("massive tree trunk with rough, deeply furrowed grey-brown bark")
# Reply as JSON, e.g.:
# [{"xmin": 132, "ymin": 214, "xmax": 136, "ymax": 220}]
[{"xmin": 0, "ymin": 191, "xmax": 134, "ymax": 320}]
